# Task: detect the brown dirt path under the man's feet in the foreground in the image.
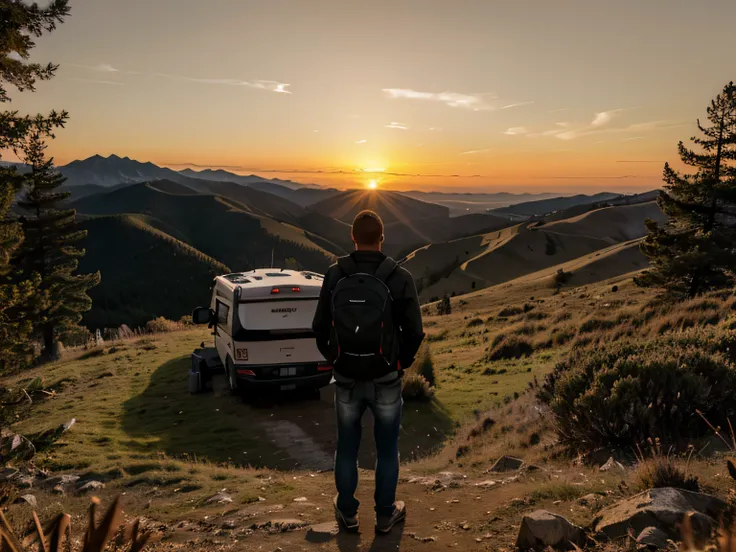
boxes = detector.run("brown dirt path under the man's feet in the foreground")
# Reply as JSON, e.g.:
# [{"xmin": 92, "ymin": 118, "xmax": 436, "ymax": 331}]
[{"xmin": 182, "ymin": 469, "xmax": 528, "ymax": 552}]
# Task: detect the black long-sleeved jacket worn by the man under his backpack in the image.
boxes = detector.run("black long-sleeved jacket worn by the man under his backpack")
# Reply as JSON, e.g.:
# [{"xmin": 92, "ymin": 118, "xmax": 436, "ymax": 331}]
[{"xmin": 312, "ymin": 251, "xmax": 424, "ymax": 376}]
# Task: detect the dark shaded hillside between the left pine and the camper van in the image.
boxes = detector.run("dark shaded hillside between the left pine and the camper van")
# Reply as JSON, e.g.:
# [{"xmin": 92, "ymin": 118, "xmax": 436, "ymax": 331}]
[{"xmin": 79, "ymin": 215, "xmax": 230, "ymax": 329}]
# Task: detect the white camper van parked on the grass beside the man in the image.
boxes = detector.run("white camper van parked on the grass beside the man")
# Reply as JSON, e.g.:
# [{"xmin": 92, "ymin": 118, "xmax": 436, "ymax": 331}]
[{"xmin": 193, "ymin": 268, "xmax": 332, "ymax": 393}]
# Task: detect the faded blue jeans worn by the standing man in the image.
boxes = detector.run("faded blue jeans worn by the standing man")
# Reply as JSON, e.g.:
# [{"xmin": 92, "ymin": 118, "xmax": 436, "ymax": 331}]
[{"xmin": 335, "ymin": 376, "xmax": 404, "ymax": 516}]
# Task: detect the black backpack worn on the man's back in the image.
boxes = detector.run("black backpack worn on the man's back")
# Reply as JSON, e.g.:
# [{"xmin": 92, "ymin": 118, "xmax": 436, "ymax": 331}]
[{"xmin": 332, "ymin": 257, "xmax": 398, "ymax": 380}]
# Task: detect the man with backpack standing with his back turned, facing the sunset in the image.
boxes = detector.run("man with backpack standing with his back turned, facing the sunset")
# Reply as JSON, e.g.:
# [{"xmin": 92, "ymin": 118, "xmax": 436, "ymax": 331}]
[{"xmin": 313, "ymin": 211, "xmax": 424, "ymax": 533}]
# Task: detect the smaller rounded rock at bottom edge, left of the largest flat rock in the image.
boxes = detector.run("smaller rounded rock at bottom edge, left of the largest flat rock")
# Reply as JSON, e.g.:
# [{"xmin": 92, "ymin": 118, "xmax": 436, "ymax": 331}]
[{"xmin": 516, "ymin": 510, "xmax": 586, "ymax": 550}]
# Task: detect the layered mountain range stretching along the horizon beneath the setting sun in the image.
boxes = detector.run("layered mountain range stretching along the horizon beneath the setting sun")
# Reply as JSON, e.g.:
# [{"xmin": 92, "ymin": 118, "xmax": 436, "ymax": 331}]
[{"xmin": 4, "ymin": 155, "xmax": 661, "ymax": 329}]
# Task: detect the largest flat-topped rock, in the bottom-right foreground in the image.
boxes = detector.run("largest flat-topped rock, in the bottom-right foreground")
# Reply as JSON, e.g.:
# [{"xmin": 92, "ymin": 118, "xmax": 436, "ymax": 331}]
[{"xmin": 594, "ymin": 488, "xmax": 726, "ymax": 540}]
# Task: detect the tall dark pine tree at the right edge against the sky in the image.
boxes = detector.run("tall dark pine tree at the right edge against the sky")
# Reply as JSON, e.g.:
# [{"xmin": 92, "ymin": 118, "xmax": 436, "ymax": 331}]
[{"xmin": 636, "ymin": 82, "xmax": 736, "ymax": 297}]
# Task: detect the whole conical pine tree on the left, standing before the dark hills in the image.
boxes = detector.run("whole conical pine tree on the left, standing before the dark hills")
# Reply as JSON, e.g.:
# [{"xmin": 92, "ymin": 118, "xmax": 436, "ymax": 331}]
[{"xmin": 14, "ymin": 133, "xmax": 100, "ymax": 358}]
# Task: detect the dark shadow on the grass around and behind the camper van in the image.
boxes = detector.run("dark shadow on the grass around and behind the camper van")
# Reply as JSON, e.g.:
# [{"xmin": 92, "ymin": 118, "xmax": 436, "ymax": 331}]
[{"xmin": 119, "ymin": 357, "xmax": 454, "ymax": 470}]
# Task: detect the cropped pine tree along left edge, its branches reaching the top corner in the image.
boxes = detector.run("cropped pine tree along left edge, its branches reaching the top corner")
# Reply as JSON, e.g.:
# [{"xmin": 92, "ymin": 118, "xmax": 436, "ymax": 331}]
[{"xmin": 0, "ymin": 0, "xmax": 69, "ymax": 373}]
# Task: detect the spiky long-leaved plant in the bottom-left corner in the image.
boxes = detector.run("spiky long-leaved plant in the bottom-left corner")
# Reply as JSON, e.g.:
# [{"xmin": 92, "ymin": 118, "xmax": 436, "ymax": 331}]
[{"xmin": 0, "ymin": 497, "xmax": 153, "ymax": 552}]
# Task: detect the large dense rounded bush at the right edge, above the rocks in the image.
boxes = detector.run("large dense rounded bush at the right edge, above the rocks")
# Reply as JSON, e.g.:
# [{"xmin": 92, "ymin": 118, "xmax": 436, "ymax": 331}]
[{"xmin": 537, "ymin": 332, "xmax": 736, "ymax": 451}]
